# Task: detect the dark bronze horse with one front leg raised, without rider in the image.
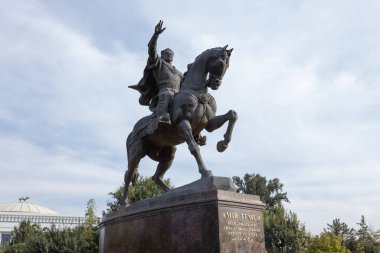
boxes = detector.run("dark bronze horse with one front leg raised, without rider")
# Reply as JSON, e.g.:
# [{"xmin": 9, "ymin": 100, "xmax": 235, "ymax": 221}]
[{"xmin": 122, "ymin": 45, "xmax": 238, "ymax": 206}]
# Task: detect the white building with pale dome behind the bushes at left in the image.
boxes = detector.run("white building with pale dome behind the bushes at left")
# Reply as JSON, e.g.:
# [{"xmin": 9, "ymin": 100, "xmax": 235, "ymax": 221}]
[{"xmin": 0, "ymin": 198, "xmax": 84, "ymax": 245}]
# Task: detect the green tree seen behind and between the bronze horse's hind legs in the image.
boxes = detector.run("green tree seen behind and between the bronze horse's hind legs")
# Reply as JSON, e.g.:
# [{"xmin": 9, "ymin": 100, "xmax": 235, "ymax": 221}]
[{"xmin": 103, "ymin": 177, "xmax": 174, "ymax": 214}]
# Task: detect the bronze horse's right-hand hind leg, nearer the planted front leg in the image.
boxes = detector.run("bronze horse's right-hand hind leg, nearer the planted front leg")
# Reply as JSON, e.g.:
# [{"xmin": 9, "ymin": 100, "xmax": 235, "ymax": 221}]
[{"xmin": 152, "ymin": 146, "xmax": 177, "ymax": 192}]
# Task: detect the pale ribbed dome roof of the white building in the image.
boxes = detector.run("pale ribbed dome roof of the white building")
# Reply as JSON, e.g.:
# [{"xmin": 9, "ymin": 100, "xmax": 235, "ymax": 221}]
[{"xmin": 0, "ymin": 201, "xmax": 58, "ymax": 215}]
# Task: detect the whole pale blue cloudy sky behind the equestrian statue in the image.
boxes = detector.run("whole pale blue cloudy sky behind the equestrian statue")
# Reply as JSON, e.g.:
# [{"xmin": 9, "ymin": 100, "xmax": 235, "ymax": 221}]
[{"xmin": 0, "ymin": 0, "xmax": 380, "ymax": 234}]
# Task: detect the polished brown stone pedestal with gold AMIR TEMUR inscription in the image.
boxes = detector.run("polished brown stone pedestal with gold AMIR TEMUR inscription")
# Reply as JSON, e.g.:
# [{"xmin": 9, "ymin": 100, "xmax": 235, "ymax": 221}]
[{"xmin": 100, "ymin": 177, "xmax": 265, "ymax": 253}]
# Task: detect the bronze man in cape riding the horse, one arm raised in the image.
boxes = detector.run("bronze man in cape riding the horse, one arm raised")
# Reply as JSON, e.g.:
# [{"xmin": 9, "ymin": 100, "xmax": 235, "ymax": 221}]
[{"xmin": 130, "ymin": 20, "xmax": 183, "ymax": 124}]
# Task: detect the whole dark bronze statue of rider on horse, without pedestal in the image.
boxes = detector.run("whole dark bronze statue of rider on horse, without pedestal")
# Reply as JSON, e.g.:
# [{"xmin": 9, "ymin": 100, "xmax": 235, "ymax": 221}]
[{"xmin": 123, "ymin": 21, "xmax": 238, "ymax": 205}]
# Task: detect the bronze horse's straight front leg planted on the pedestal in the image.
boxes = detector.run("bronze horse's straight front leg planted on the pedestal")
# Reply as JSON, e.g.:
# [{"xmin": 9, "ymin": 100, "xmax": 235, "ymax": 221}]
[{"xmin": 178, "ymin": 120, "xmax": 212, "ymax": 178}]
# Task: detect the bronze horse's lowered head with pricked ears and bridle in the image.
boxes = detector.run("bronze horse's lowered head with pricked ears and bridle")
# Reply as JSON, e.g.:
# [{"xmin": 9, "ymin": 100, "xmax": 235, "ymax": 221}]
[{"xmin": 207, "ymin": 45, "xmax": 233, "ymax": 90}]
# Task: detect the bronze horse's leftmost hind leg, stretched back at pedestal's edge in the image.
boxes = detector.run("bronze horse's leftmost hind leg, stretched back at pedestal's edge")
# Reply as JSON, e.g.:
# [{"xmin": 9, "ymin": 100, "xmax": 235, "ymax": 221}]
[{"xmin": 122, "ymin": 140, "xmax": 145, "ymax": 206}]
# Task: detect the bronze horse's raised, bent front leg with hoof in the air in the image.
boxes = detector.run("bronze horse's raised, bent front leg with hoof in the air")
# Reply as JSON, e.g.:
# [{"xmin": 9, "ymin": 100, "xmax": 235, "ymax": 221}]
[{"xmin": 205, "ymin": 110, "xmax": 238, "ymax": 152}]
